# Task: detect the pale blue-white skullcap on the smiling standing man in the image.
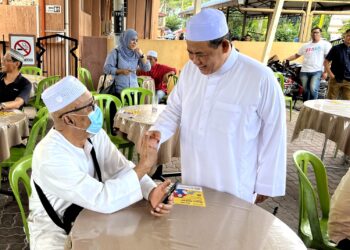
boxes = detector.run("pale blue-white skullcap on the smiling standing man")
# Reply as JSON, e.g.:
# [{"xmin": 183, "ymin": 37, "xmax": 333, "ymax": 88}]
[{"xmin": 186, "ymin": 8, "xmax": 228, "ymax": 42}]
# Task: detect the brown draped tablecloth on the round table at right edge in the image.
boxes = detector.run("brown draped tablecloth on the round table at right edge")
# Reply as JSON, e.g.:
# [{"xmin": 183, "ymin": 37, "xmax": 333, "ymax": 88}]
[{"xmin": 292, "ymin": 99, "xmax": 350, "ymax": 155}]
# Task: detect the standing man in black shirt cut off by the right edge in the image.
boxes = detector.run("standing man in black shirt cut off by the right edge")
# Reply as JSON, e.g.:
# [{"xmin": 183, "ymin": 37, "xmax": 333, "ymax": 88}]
[{"xmin": 324, "ymin": 29, "xmax": 350, "ymax": 100}]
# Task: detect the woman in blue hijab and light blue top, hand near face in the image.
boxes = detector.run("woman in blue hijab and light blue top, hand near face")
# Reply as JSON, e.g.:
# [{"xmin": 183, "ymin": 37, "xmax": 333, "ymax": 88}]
[{"xmin": 103, "ymin": 29, "xmax": 151, "ymax": 96}]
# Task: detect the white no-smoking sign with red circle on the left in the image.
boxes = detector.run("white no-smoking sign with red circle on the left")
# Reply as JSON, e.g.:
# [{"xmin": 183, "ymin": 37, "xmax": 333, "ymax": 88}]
[{"xmin": 9, "ymin": 34, "xmax": 35, "ymax": 65}]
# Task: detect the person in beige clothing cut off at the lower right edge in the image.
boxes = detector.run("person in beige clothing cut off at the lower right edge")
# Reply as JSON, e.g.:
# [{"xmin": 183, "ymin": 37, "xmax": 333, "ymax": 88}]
[{"xmin": 328, "ymin": 169, "xmax": 350, "ymax": 249}]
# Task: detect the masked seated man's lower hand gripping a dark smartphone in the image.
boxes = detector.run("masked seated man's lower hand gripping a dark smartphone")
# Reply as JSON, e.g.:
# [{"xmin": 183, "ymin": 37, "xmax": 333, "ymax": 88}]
[{"xmin": 148, "ymin": 180, "xmax": 174, "ymax": 216}]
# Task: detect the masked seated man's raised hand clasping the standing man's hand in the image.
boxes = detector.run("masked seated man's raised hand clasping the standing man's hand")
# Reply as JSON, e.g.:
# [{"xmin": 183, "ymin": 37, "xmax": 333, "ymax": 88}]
[{"xmin": 134, "ymin": 132, "xmax": 158, "ymax": 179}]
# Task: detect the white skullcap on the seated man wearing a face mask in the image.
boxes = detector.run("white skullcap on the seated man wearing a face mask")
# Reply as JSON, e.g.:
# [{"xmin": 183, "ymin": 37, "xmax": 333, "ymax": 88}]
[{"xmin": 41, "ymin": 76, "xmax": 88, "ymax": 113}]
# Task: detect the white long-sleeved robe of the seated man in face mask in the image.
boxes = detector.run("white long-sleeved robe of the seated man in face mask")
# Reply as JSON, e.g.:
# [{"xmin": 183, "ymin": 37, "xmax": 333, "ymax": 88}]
[{"xmin": 28, "ymin": 129, "xmax": 156, "ymax": 249}]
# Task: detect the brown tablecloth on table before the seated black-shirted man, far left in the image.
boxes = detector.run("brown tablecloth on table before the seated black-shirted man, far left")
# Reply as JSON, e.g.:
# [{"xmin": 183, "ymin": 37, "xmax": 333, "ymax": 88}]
[{"xmin": 0, "ymin": 110, "xmax": 29, "ymax": 161}]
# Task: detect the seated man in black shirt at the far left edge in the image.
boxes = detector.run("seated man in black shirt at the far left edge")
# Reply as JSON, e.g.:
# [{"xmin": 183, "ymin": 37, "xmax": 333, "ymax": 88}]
[{"xmin": 0, "ymin": 49, "xmax": 32, "ymax": 110}]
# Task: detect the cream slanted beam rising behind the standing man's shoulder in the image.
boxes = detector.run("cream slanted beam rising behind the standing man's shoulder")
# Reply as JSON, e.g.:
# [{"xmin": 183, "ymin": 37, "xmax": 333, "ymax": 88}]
[{"xmin": 262, "ymin": 0, "xmax": 284, "ymax": 64}]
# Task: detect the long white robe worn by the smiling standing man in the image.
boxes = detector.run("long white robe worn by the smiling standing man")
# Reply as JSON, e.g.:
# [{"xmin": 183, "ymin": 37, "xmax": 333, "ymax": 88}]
[{"xmin": 150, "ymin": 50, "xmax": 286, "ymax": 202}]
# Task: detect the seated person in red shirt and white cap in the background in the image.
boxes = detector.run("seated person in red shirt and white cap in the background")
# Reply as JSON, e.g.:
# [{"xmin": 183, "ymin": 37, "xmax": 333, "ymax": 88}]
[{"xmin": 137, "ymin": 50, "xmax": 176, "ymax": 102}]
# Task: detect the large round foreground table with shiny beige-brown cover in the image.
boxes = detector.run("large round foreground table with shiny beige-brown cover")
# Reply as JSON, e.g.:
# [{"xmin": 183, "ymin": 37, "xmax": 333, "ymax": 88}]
[{"xmin": 68, "ymin": 188, "xmax": 306, "ymax": 250}]
